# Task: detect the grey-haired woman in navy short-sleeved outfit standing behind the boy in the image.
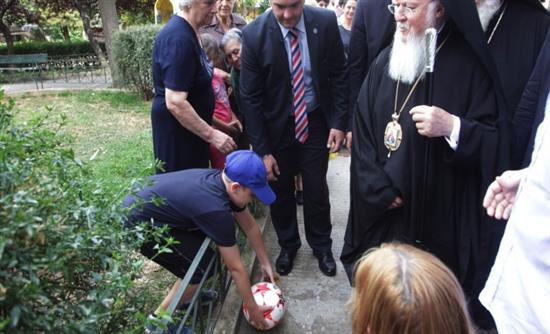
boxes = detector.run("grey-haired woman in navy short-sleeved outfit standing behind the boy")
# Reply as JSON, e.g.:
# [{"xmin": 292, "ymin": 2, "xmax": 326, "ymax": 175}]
[{"xmin": 151, "ymin": 0, "xmax": 236, "ymax": 173}]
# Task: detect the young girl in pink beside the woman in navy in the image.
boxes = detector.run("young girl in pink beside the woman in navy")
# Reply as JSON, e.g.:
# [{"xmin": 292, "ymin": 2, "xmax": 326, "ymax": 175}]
[{"xmin": 201, "ymin": 34, "xmax": 243, "ymax": 169}]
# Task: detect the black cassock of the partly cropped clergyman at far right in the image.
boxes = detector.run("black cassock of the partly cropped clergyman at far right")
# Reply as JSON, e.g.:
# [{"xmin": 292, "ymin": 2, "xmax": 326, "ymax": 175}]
[{"xmin": 483, "ymin": 0, "xmax": 550, "ymax": 175}]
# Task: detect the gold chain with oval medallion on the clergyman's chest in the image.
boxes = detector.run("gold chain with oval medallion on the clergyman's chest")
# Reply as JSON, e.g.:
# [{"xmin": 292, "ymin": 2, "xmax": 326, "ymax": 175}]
[{"xmin": 384, "ymin": 33, "xmax": 451, "ymax": 159}]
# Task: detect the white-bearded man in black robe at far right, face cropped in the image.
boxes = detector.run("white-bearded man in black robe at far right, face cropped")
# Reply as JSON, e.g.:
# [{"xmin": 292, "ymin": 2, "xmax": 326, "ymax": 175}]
[{"xmin": 471, "ymin": 0, "xmax": 550, "ymax": 329}]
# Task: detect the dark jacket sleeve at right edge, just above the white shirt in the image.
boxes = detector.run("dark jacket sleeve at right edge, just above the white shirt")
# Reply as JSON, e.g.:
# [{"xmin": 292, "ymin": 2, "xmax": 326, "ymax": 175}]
[{"xmin": 514, "ymin": 33, "xmax": 550, "ymax": 167}]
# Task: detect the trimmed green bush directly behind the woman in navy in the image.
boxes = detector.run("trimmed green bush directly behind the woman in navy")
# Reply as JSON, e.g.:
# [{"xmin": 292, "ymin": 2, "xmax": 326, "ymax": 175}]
[{"xmin": 113, "ymin": 24, "xmax": 160, "ymax": 100}]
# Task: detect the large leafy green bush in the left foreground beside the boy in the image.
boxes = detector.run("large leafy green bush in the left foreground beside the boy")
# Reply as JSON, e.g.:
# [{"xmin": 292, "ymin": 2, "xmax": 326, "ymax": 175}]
[{"xmin": 0, "ymin": 91, "xmax": 152, "ymax": 333}]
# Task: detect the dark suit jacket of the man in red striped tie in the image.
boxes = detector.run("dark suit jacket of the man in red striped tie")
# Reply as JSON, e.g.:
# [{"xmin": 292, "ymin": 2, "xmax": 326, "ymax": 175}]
[{"xmin": 240, "ymin": 6, "xmax": 348, "ymax": 156}]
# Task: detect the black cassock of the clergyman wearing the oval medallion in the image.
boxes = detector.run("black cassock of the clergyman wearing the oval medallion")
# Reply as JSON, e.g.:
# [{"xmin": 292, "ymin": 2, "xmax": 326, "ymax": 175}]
[{"xmin": 341, "ymin": 23, "xmax": 498, "ymax": 283}]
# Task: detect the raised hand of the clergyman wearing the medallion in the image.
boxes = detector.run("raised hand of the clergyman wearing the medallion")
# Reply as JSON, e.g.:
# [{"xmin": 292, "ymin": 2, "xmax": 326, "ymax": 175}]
[{"xmin": 409, "ymin": 106, "xmax": 454, "ymax": 138}]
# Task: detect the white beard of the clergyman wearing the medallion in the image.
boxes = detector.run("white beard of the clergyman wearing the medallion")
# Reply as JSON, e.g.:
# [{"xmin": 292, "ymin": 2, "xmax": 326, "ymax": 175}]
[{"xmin": 389, "ymin": 27, "xmax": 426, "ymax": 84}]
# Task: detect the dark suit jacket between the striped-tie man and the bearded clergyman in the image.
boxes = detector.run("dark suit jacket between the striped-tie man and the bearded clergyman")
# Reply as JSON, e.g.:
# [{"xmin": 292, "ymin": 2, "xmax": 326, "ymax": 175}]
[{"xmin": 348, "ymin": 0, "xmax": 395, "ymax": 121}]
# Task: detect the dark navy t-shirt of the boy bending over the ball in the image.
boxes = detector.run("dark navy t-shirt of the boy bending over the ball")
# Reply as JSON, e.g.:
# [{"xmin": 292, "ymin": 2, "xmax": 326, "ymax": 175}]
[{"xmin": 123, "ymin": 169, "xmax": 238, "ymax": 247}]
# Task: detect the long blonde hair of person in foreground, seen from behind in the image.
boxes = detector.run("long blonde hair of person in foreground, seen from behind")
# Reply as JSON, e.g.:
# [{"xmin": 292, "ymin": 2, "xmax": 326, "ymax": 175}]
[{"xmin": 348, "ymin": 243, "xmax": 474, "ymax": 334}]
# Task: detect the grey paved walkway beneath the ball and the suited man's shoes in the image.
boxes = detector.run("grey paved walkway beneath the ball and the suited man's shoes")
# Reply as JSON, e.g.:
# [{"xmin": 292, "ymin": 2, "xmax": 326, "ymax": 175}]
[{"xmin": 237, "ymin": 155, "xmax": 351, "ymax": 334}]
